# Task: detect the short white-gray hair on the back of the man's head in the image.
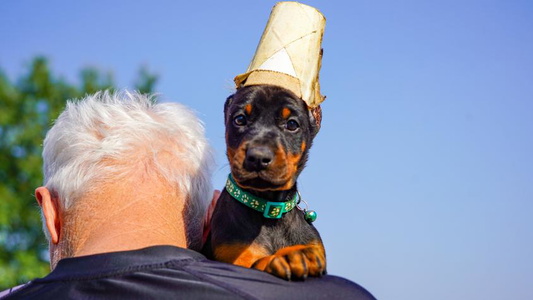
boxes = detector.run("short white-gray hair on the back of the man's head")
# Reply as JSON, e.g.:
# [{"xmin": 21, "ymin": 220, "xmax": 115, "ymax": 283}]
[{"xmin": 43, "ymin": 92, "xmax": 214, "ymax": 250}]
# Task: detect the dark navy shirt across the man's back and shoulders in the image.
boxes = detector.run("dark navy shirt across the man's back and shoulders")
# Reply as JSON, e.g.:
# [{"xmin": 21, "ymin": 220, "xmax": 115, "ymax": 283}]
[{"xmin": 2, "ymin": 246, "xmax": 375, "ymax": 300}]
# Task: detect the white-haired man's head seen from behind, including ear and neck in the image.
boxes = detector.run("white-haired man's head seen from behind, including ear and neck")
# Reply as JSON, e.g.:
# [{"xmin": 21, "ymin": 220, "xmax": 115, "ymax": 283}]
[{"xmin": 36, "ymin": 92, "xmax": 214, "ymax": 267}]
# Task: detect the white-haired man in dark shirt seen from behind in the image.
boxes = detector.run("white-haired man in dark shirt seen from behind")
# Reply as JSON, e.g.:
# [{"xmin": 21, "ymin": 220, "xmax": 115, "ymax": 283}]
[{"xmin": 1, "ymin": 92, "xmax": 373, "ymax": 299}]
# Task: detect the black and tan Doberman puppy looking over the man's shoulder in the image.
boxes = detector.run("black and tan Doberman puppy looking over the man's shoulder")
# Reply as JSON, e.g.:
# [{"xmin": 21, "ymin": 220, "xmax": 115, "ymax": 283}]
[{"xmin": 203, "ymin": 85, "xmax": 326, "ymax": 280}]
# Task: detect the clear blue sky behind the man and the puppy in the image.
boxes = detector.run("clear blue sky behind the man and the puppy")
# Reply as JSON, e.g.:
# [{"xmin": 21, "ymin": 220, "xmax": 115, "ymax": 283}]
[{"xmin": 0, "ymin": 0, "xmax": 533, "ymax": 300}]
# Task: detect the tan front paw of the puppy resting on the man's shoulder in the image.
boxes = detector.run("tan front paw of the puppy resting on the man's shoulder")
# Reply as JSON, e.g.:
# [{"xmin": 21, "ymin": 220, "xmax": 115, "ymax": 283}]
[{"xmin": 252, "ymin": 243, "xmax": 326, "ymax": 280}]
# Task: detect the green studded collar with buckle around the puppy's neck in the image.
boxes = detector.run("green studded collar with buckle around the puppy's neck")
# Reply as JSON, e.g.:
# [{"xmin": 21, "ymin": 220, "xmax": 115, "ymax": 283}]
[{"xmin": 226, "ymin": 174, "xmax": 300, "ymax": 219}]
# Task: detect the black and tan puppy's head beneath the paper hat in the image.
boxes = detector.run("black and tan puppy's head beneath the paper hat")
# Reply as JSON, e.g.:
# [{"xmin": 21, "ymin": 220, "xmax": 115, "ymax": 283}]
[{"xmin": 224, "ymin": 85, "xmax": 321, "ymax": 191}]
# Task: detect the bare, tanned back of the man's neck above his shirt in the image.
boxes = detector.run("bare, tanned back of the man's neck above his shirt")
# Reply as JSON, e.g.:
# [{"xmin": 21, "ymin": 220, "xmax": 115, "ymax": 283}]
[{"xmin": 52, "ymin": 193, "xmax": 187, "ymax": 268}]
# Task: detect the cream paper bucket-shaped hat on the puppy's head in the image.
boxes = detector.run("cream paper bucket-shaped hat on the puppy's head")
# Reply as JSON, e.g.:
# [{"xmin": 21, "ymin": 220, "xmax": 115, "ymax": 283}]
[{"xmin": 235, "ymin": 2, "xmax": 326, "ymax": 108}]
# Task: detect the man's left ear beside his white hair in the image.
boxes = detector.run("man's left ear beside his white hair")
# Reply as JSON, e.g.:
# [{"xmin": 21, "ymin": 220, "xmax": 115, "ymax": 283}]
[{"xmin": 35, "ymin": 186, "xmax": 61, "ymax": 244}]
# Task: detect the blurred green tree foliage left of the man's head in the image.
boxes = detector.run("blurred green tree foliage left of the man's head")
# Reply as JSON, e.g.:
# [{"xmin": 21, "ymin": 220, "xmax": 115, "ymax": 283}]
[{"xmin": 0, "ymin": 57, "xmax": 157, "ymax": 290}]
